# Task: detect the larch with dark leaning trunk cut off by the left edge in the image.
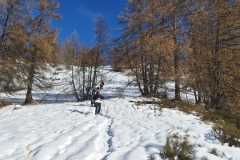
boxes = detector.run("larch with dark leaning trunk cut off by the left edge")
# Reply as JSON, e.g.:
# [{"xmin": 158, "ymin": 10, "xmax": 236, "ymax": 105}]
[{"xmin": 0, "ymin": 0, "xmax": 30, "ymax": 93}]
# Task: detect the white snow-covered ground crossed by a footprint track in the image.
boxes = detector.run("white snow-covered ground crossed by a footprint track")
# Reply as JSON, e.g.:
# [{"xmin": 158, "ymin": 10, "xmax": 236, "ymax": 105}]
[{"xmin": 0, "ymin": 66, "xmax": 240, "ymax": 160}]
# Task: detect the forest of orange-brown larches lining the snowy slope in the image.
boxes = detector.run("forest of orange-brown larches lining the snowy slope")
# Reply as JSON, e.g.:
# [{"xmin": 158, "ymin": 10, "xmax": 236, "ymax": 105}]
[{"xmin": 0, "ymin": 0, "xmax": 240, "ymax": 113}]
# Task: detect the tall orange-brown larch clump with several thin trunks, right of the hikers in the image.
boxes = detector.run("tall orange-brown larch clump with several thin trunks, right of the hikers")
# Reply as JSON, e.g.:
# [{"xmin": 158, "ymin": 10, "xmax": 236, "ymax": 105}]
[{"xmin": 118, "ymin": 0, "xmax": 174, "ymax": 96}]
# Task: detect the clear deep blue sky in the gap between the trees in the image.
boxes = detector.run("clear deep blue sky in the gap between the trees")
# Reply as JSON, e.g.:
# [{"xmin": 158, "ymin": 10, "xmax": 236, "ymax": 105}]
[{"xmin": 53, "ymin": 0, "xmax": 127, "ymax": 47}]
